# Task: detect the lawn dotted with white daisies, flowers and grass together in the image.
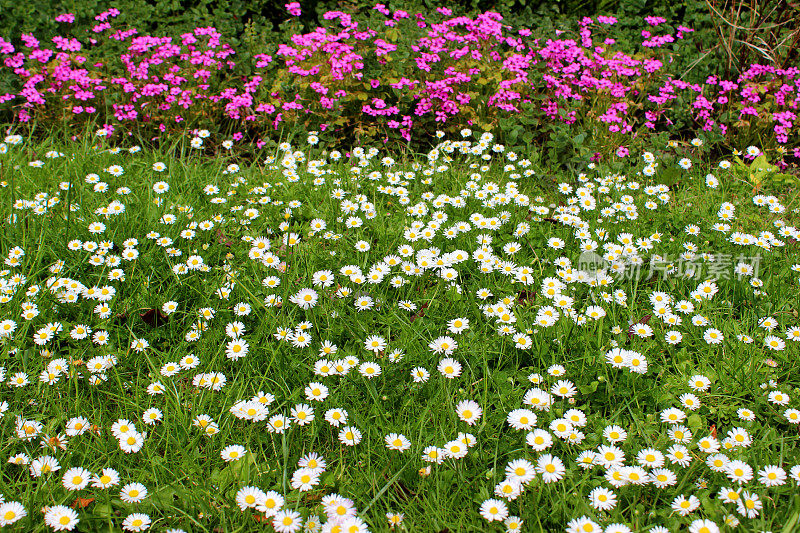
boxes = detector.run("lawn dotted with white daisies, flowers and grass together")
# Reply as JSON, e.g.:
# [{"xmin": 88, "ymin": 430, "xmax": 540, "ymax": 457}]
[{"xmin": 0, "ymin": 121, "xmax": 800, "ymax": 533}]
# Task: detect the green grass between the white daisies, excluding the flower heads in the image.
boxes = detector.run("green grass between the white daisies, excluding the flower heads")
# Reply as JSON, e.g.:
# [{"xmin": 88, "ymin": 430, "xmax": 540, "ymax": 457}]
[{"xmin": 0, "ymin": 130, "xmax": 800, "ymax": 532}]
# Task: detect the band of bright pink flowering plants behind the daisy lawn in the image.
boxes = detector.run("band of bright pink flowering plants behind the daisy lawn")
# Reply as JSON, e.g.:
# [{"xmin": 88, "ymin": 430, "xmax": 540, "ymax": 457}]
[{"xmin": 0, "ymin": 2, "xmax": 800, "ymax": 160}]
